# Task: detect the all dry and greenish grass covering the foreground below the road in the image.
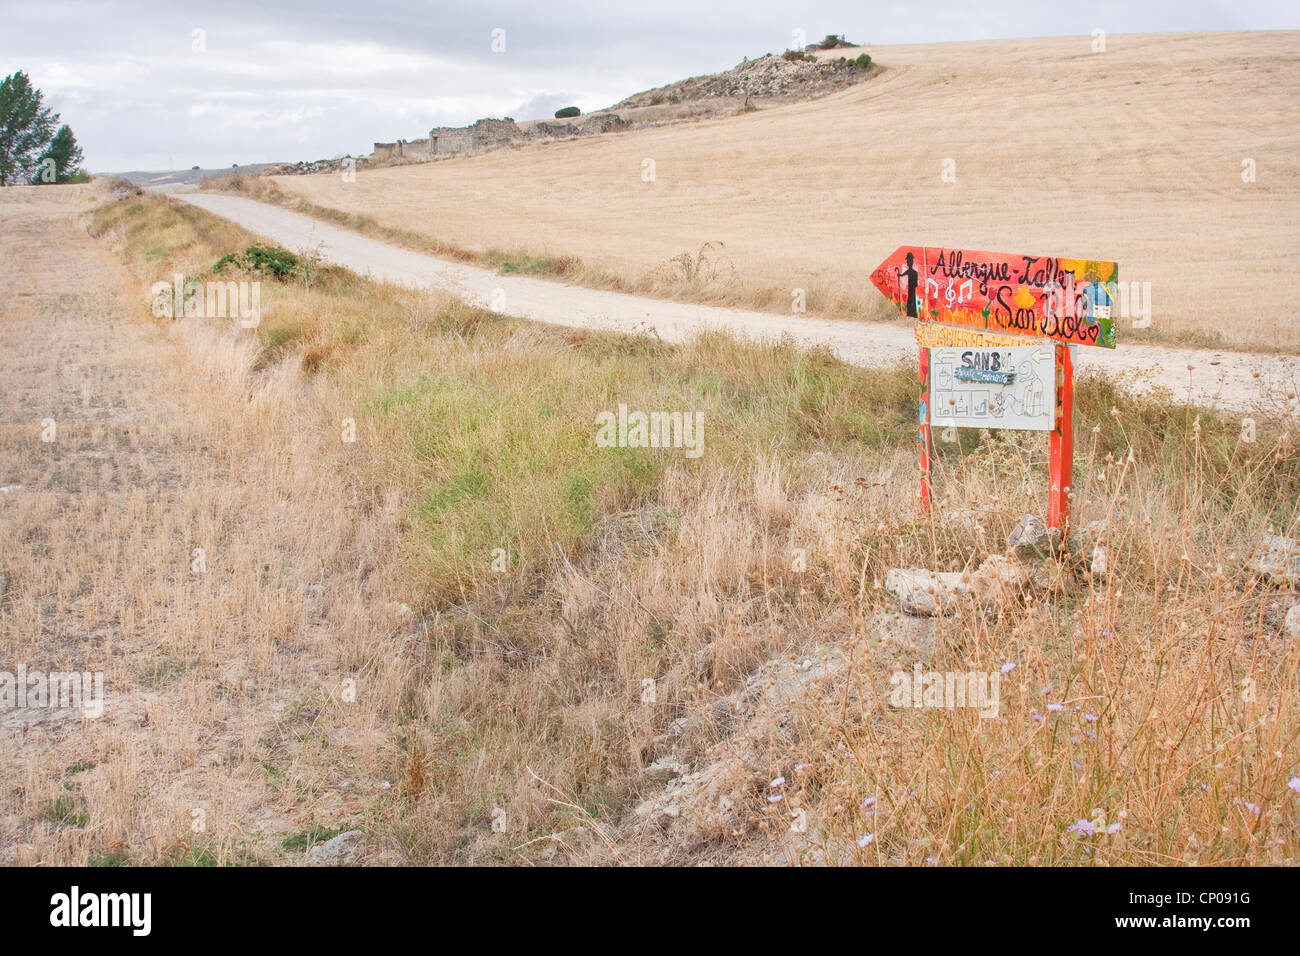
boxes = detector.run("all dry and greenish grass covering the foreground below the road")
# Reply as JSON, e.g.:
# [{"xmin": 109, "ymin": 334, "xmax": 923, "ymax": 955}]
[{"xmin": 0, "ymin": 187, "xmax": 1300, "ymax": 864}]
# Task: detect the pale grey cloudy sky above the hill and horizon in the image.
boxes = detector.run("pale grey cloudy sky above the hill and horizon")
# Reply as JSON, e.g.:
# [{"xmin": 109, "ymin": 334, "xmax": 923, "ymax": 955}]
[{"xmin": 0, "ymin": 0, "xmax": 1300, "ymax": 172}]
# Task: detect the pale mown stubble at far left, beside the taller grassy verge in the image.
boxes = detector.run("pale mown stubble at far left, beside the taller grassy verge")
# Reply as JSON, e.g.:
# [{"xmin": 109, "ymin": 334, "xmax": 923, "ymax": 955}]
[{"xmin": 0, "ymin": 190, "xmax": 402, "ymax": 865}]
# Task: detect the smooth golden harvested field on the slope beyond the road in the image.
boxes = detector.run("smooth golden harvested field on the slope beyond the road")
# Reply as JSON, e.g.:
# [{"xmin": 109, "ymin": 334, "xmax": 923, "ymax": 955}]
[{"xmin": 276, "ymin": 31, "xmax": 1300, "ymax": 351}]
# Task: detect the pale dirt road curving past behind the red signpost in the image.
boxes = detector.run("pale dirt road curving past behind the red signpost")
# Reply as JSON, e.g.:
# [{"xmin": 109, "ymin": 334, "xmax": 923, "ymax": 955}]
[{"xmin": 177, "ymin": 193, "xmax": 1300, "ymax": 411}]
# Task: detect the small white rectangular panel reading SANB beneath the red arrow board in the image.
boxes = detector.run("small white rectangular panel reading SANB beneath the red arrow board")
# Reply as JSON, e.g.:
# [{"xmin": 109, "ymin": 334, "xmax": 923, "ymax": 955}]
[{"xmin": 930, "ymin": 343, "xmax": 1056, "ymax": 432}]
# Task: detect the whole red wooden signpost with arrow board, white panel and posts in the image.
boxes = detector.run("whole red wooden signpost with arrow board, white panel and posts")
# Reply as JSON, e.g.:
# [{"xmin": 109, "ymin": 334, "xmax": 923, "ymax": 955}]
[{"xmin": 871, "ymin": 246, "xmax": 1119, "ymax": 535}]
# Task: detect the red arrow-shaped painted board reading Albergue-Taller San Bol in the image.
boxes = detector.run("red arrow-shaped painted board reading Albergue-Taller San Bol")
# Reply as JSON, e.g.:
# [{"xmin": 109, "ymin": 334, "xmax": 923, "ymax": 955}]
[{"xmin": 871, "ymin": 246, "xmax": 1119, "ymax": 349}]
